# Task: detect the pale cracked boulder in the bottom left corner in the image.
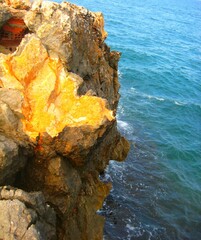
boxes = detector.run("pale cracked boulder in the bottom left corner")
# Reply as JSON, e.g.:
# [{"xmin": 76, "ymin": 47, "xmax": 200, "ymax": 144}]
[{"xmin": 0, "ymin": 186, "xmax": 56, "ymax": 240}]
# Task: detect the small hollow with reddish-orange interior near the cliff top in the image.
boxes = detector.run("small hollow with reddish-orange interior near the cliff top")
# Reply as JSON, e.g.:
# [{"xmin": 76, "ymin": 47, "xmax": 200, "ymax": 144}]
[{"xmin": 0, "ymin": 17, "xmax": 30, "ymax": 54}]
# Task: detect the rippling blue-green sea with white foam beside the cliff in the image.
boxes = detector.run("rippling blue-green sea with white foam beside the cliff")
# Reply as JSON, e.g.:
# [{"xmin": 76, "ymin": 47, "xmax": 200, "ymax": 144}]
[{"xmin": 55, "ymin": 0, "xmax": 201, "ymax": 240}]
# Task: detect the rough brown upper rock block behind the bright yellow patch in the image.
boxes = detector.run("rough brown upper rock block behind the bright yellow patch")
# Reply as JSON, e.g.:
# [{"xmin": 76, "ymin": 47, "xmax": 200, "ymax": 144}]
[{"xmin": 24, "ymin": 2, "xmax": 120, "ymax": 110}]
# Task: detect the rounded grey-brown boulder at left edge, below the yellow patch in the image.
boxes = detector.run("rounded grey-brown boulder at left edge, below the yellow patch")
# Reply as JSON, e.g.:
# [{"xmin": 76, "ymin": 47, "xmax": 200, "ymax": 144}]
[{"xmin": 0, "ymin": 88, "xmax": 31, "ymax": 185}]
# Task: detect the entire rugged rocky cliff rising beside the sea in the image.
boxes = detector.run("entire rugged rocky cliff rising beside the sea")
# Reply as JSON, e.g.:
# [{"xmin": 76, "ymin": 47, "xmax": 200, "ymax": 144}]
[{"xmin": 0, "ymin": 0, "xmax": 129, "ymax": 240}]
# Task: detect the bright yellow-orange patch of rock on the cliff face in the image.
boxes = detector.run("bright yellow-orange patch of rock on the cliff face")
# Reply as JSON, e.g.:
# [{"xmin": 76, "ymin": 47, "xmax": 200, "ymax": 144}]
[{"xmin": 0, "ymin": 37, "xmax": 114, "ymax": 138}]
